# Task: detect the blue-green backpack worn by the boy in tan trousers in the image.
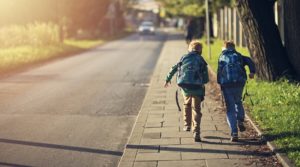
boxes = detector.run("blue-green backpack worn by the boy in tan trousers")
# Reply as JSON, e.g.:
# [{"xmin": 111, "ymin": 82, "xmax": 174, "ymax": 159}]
[{"xmin": 177, "ymin": 52, "xmax": 207, "ymax": 89}]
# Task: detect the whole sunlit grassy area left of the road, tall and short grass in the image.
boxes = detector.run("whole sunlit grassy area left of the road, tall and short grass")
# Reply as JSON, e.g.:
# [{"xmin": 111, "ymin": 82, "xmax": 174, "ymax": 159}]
[{"xmin": 0, "ymin": 23, "xmax": 104, "ymax": 73}]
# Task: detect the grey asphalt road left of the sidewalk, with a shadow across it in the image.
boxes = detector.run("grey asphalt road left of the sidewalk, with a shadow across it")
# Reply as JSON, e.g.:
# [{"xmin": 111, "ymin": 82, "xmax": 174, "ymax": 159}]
[{"xmin": 0, "ymin": 34, "xmax": 166, "ymax": 167}]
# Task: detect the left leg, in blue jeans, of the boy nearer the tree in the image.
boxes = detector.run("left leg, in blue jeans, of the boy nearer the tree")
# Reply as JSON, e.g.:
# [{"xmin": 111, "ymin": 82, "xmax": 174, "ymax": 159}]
[{"xmin": 222, "ymin": 88, "xmax": 238, "ymax": 137}]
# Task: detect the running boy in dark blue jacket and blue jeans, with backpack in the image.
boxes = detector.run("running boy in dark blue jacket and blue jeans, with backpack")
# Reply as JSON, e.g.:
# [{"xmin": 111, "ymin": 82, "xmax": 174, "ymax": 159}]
[{"xmin": 217, "ymin": 41, "xmax": 255, "ymax": 142}]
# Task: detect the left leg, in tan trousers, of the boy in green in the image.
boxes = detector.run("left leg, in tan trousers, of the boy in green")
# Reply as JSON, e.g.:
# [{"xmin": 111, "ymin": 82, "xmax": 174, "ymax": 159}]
[{"xmin": 182, "ymin": 95, "xmax": 192, "ymax": 131}]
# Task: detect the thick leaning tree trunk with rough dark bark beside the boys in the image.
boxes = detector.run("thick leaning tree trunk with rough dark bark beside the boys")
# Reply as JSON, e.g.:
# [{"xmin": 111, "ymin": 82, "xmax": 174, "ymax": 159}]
[{"xmin": 236, "ymin": 0, "xmax": 293, "ymax": 81}]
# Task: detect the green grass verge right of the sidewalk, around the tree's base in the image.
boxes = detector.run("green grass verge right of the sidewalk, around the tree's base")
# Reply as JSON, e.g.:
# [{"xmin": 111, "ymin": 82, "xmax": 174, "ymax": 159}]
[{"xmin": 201, "ymin": 39, "xmax": 300, "ymax": 167}]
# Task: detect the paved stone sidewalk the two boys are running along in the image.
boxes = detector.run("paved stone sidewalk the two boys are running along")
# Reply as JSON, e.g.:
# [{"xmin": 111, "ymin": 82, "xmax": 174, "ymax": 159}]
[{"xmin": 119, "ymin": 32, "xmax": 273, "ymax": 167}]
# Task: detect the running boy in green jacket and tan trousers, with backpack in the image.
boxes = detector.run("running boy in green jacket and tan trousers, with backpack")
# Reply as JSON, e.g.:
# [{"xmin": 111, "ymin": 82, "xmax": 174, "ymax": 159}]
[{"xmin": 165, "ymin": 41, "xmax": 208, "ymax": 142}]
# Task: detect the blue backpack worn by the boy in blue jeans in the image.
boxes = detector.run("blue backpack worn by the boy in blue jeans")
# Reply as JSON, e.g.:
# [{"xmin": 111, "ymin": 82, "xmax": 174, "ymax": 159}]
[{"xmin": 218, "ymin": 50, "xmax": 247, "ymax": 85}]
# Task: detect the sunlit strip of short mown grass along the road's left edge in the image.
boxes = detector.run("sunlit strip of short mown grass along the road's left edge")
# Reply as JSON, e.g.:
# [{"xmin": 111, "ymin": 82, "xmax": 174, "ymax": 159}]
[{"xmin": 0, "ymin": 40, "xmax": 104, "ymax": 73}]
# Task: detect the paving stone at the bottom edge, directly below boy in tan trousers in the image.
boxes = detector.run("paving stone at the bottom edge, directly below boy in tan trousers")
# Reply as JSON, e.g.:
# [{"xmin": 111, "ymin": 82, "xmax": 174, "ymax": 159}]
[{"xmin": 158, "ymin": 160, "xmax": 206, "ymax": 167}]
